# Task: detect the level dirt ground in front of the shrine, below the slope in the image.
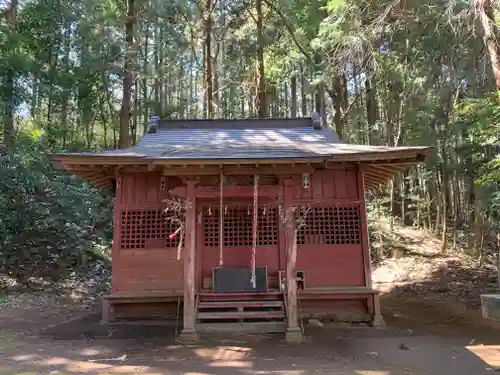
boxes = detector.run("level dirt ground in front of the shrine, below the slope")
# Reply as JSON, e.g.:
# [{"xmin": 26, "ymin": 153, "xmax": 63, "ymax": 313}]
[{"xmin": 0, "ymin": 295, "xmax": 500, "ymax": 375}]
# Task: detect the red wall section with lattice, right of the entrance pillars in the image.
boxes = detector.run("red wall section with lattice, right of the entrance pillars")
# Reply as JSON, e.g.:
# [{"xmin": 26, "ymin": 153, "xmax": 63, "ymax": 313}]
[{"xmin": 292, "ymin": 169, "xmax": 365, "ymax": 288}]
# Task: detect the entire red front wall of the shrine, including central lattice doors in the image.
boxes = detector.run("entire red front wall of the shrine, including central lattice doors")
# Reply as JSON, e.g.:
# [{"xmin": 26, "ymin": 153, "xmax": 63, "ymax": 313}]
[{"xmin": 113, "ymin": 168, "xmax": 367, "ymax": 315}]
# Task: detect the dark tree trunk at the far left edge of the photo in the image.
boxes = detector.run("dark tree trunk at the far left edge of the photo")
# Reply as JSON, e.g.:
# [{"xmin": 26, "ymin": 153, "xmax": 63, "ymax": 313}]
[{"xmin": 2, "ymin": 0, "xmax": 18, "ymax": 146}]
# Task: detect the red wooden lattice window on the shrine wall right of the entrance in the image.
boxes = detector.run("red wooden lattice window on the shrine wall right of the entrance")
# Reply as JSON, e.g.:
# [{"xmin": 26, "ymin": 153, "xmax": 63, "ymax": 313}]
[{"xmin": 297, "ymin": 206, "xmax": 361, "ymax": 245}]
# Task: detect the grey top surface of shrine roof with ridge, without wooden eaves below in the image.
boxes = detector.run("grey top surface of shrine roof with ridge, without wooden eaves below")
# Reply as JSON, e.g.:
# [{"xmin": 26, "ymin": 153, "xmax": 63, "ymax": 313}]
[{"xmin": 55, "ymin": 118, "xmax": 427, "ymax": 161}]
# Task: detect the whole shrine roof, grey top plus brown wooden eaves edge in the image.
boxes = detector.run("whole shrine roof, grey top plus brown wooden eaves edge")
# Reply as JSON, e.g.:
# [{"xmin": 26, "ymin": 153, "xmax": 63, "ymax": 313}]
[{"xmin": 50, "ymin": 117, "xmax": 430, "ymax": 191}]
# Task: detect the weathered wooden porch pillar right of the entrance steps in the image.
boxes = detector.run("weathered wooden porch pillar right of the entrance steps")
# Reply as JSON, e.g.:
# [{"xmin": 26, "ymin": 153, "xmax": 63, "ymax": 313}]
[{"xmin": 284, "ymin": 180, "xmax": 303, "ymax": 342}]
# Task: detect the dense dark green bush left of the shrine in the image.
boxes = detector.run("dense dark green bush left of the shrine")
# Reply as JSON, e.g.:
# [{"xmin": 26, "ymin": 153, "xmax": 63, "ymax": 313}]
[{"xmin": 0, "ymin": 137, "xmax": 112, "ymax": 279}]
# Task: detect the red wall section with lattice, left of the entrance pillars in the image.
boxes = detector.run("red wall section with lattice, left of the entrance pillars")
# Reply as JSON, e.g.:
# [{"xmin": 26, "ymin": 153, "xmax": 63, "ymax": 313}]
[{"xmin": 113, "ymin": 172, "xmax": 183, "ymax": 292}]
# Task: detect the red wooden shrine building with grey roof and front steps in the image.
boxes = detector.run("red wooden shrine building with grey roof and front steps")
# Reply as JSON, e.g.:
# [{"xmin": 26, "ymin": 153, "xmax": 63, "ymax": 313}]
[{"xmin": 50, "ymin": 118, "xmax": 430, "ymax": 341}]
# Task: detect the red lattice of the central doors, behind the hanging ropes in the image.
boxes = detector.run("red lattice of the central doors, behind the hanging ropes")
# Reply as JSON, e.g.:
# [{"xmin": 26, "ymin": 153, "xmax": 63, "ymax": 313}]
[{"xmin": 204, "ymin": 207, "xmax": 278, "ymax": 247}]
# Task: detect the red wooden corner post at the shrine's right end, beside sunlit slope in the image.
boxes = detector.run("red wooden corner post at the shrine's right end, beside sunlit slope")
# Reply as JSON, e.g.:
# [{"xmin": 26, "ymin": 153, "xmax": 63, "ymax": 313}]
[{"xmin": 357, "ymin": 166, "xmax": 385, "ymax": 327}]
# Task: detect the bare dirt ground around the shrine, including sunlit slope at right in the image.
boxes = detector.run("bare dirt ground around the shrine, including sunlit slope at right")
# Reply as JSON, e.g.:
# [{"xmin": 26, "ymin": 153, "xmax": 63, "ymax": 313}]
[{"xmin": 0, "ymin": 228, "xmax": 500, "ymax": 375}]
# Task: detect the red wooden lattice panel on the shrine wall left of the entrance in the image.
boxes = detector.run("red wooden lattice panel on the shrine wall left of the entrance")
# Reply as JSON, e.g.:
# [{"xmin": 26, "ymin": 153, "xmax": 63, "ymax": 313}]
[{"xmin": 120, "ymin": 210, "xmax": 179, "ymax": 249}]
